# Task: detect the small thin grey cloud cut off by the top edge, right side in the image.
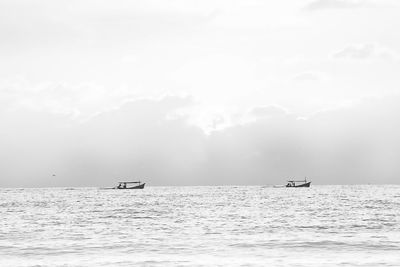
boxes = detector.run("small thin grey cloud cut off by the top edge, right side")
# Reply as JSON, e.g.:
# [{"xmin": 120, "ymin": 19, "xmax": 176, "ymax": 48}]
[{"xmin": 304, "ymin": 0, "xmax": 370, "ymax": 11}]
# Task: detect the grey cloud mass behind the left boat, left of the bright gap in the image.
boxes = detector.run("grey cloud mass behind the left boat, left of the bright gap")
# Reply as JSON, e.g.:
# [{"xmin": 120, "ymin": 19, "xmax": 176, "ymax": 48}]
[{"xmin": 0, "ymin": 96, "xmax": 205, "ymax": 186}]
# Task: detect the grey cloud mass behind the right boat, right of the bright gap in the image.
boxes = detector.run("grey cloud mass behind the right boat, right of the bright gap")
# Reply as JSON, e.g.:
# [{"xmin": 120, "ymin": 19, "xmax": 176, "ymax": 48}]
[{"xmin": 208, "ymin": 97, "xmax": 400, "ymax": 184}]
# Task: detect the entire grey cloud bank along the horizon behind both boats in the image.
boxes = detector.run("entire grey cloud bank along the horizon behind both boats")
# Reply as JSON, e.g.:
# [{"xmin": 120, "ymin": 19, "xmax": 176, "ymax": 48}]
[{"xmin": 0, "ymin": 97, "xmax": 400, "ymax": 187}]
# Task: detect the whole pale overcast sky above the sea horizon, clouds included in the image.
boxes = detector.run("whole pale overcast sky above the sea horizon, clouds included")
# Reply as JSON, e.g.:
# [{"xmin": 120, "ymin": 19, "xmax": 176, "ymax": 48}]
[{"xmin": 0, "ymin": 0, "xmax": 400, "ymax": 187}]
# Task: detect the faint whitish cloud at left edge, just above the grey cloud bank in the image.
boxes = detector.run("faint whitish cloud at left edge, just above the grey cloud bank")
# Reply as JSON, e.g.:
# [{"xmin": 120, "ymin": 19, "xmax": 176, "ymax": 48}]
[{"xmin": 0, "ymin": 79, "xmax": 139, "ymax": 119}]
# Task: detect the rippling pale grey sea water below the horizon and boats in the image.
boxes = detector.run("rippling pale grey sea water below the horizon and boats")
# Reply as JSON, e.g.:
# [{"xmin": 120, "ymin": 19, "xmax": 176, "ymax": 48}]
[{"xmin": 0, "ymin": 185, "xmax": 400, "ymax": 267}]
